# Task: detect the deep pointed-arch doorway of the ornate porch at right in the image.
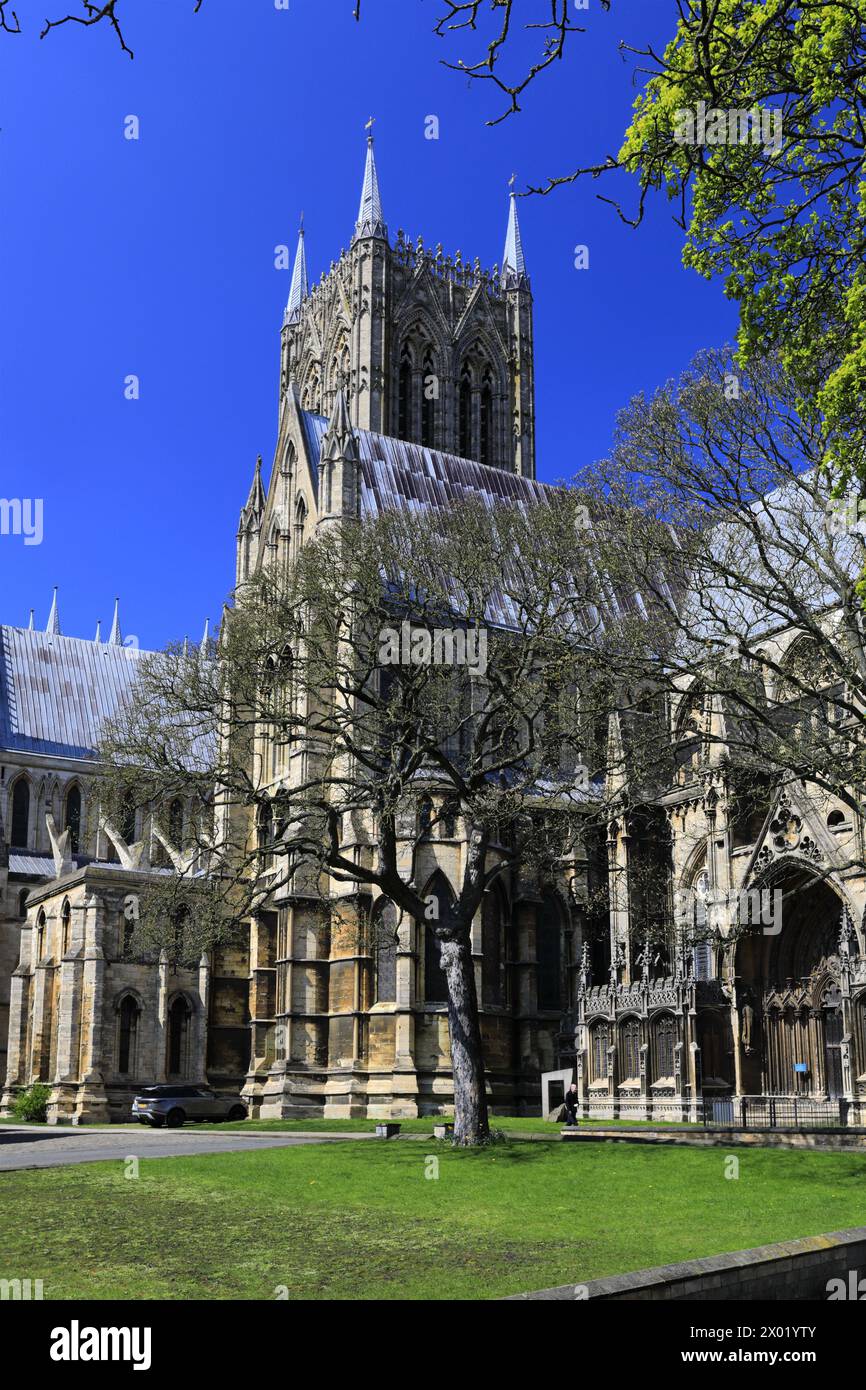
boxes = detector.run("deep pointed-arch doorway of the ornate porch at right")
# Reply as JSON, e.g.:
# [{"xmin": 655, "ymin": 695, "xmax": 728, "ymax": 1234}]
[{"xmin": 735, "ymin": 865, "xmax": 844, "ymax": 1099}]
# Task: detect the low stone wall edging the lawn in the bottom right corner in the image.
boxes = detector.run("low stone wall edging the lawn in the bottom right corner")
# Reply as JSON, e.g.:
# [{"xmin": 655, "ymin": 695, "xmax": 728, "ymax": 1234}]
[{"xmin": 503, "ymin": 1226, "xmax": 866, "ymax": 1302}]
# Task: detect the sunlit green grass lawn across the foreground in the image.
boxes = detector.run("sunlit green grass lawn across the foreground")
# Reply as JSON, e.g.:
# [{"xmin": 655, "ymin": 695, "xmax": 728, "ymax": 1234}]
[{"xmin": 0, "ymin": 1141, "xmax": 866, "ymax": 1298}]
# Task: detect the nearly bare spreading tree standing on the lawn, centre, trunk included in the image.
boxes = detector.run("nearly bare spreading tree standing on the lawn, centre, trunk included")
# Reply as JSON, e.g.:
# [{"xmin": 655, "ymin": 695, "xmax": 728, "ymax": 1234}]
[{"xmin": 103, "ymin": 489, "xmax": 637, "ymax": 1144}]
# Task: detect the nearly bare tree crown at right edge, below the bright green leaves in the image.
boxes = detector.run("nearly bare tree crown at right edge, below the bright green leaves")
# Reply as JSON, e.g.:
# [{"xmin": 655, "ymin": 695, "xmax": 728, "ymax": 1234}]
[{"xmin": 583, "ymin": 344, "xmax": 866, "ymax": 865}]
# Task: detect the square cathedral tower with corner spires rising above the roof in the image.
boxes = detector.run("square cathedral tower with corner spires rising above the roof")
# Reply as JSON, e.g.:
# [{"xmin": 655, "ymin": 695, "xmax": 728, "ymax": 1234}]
[{"xmin": 281, "ymin": 135, "xmax": 535, "ymax": 478}]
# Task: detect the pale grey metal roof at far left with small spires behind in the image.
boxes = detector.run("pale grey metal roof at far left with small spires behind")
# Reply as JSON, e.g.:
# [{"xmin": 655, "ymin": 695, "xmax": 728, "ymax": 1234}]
[{"xmin": 0, "ymin": 627, "xmax": 147, "ymax": 759}]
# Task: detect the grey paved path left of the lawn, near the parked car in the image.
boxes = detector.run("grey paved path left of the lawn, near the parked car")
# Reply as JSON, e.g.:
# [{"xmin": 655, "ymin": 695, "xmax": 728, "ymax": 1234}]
[{"xmin": 0, "ymin": 1125, "xmax": 375, "ymax": 1172}]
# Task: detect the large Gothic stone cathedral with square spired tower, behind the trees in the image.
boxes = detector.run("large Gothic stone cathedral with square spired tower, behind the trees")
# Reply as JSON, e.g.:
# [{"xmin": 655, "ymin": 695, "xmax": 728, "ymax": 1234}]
[{"xmin": 0, "ymin": 139, "xmax": 866, "ymax": 1125}]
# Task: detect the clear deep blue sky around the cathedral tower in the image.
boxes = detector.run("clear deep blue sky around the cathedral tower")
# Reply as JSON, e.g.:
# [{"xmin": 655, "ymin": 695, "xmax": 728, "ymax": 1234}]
[{"xmin": 0, "ymin": 0, "xmax": 735, "ymax": 646}]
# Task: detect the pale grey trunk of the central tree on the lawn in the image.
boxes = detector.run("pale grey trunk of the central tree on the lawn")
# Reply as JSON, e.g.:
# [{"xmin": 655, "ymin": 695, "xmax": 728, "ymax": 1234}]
[{"xmin": 442, "ymin": 933, "xmax": 489, "ymax": 1144}]
